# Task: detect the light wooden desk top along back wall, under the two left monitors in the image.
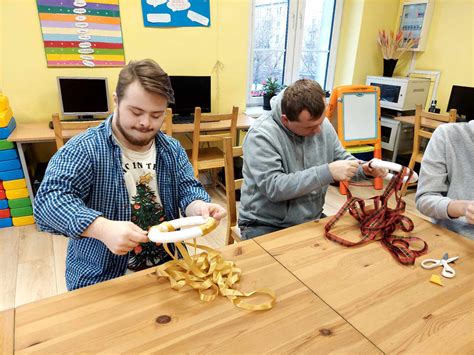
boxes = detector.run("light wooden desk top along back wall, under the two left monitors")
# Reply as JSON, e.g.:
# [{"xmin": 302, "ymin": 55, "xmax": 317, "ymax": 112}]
[{"xmin": 8, "ymin": 113, "xmax": 255, "ymax": 143}]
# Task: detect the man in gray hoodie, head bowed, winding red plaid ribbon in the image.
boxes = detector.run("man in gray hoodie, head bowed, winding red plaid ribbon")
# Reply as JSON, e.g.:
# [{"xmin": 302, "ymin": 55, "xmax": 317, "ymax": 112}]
[{"xmin": 239, "ymin": 79, "xmax": 386, "ymax": 239}]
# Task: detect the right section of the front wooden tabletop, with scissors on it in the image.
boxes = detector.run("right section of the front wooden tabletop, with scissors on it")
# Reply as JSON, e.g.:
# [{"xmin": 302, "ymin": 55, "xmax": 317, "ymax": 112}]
[{"xmin": 255, "ymin": 213, "xmax": 474, "ymax": 353}]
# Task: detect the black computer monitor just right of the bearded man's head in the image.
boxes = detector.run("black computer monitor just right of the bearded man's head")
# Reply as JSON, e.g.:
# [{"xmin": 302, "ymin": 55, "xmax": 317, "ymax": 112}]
[{"xmin": 170, "ymin": 76, "xmax": 211, "ymax": 116}]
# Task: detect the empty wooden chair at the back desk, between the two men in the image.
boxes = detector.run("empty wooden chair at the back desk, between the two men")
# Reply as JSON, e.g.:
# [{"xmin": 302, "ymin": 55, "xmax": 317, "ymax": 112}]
[{"xmin": 187, "ymin": 106, "xmax": 239, "ymax": 185}]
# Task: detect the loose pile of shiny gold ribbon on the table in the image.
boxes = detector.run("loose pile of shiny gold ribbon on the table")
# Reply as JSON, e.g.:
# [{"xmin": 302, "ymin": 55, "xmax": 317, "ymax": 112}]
[{"xmin": 156, "ymin": 239, "xmax": 276, "ymax": 311}]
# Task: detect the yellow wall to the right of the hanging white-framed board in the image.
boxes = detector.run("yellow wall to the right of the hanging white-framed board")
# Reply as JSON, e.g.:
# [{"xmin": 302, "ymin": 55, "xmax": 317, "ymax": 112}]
[{"xmin": 395, "ymin": 0, "xmax": 474, "ymax": 112}]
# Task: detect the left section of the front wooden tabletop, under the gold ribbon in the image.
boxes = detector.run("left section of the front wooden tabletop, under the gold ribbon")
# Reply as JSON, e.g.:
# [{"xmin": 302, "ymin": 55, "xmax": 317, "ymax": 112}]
[{"xmin": 15, "ymin": 241, "xmax": 381, "ymax": 354}]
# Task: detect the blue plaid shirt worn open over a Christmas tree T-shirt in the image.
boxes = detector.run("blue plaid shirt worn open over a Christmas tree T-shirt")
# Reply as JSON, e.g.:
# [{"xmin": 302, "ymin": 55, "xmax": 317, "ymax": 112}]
[{"xmin": 34, "ymin": 118, "xmax": 210, "ymax": 290}]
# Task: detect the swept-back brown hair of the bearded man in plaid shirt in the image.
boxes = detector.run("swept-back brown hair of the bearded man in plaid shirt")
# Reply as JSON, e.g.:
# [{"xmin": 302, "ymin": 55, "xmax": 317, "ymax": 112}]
[{"xmin": 115, "ymin": 59, "xmax": 174, "ymax": 104}]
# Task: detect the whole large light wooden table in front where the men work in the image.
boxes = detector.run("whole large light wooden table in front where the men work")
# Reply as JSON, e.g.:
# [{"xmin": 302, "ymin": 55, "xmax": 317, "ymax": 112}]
[{"xmin": 8, "ymin": 214, "xmax": 474, "ymax": 353}]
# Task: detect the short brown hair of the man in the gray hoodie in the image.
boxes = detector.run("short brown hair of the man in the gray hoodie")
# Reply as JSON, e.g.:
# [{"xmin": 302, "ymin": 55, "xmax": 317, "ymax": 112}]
[{"xmin": 281, "ymin": 79, "xmax": 326, "ymax": 121}]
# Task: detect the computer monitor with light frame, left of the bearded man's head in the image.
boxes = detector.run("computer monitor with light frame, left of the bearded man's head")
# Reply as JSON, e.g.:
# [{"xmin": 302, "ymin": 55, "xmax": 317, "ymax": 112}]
[{"xmin": 58, "ymin": 77, "xmax": 109, "ymax": 119}]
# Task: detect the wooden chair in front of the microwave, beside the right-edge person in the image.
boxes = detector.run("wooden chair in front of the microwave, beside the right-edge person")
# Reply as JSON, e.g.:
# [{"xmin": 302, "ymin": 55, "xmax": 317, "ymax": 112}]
[{"xmin": 400, "ymin": 105, "xmax": 456, "ymax": 196}]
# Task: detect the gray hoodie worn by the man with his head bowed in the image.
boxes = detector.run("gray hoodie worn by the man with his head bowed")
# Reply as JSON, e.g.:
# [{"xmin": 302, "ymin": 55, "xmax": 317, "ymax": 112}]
[{"xmin": 239, "ymin": 92, "xmax": 365, "ymax": 228}]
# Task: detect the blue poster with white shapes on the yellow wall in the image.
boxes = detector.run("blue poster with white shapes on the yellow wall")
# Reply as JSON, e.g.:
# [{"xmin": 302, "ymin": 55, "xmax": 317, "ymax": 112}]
[{"xmin": 142, "ymin": 0, "xmax": 211, "ymax": 27}]
